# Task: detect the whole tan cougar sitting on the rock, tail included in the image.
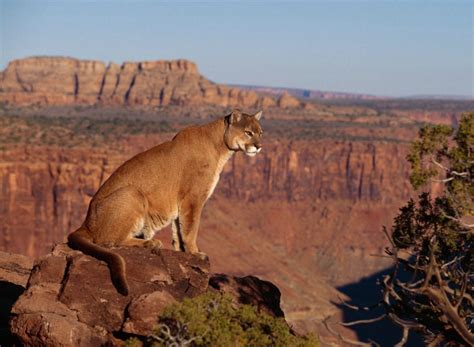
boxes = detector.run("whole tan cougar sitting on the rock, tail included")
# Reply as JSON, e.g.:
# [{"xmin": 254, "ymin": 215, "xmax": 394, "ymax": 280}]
[{"xmin": 68, "ymin": 110, "xmax": 262, "ymax": 295}]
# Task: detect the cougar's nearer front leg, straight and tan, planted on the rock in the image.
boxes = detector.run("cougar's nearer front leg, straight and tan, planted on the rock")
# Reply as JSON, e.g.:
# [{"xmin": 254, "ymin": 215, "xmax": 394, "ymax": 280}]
[{"xmin": 178, "ymin": 201, "xmax": 207, "ymax": 258}]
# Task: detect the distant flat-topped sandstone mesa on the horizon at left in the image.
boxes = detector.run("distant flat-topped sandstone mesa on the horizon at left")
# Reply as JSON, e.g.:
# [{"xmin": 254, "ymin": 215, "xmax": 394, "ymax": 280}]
[{"xmin": 0, "ymin": 57, "xmax": 303, "ymax": 108}]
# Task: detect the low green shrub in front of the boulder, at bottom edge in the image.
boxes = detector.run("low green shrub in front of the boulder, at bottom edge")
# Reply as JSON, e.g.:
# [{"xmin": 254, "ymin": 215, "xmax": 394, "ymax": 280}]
[{"xmin": 131, "ymin": 293, "xmax": 319, "ymax": 347}]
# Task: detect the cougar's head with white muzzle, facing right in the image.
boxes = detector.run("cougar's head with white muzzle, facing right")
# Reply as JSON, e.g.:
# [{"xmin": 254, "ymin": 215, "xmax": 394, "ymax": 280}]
[{"xmin": 224, "ymin": 110, "xmax": 263, "ymax": 157}]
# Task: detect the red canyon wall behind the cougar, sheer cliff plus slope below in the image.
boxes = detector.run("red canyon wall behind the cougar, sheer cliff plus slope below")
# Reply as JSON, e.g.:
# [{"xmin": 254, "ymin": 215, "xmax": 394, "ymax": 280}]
[{"xmin": 0, "ymin": 134, "xmax": 411, "ymax": 338}]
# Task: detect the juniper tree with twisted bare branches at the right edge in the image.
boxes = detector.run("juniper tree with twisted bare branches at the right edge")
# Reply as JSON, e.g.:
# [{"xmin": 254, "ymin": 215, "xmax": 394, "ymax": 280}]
[{"xmin": 346, "ymin": 112, "xmax": 474, "ymax": 346}]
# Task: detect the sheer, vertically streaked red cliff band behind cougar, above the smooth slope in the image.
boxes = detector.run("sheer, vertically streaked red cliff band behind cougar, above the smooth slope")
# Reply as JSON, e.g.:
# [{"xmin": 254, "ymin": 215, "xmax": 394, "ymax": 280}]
[{"xmin": 0, "ymin": 138, "xmax": 412, "ymax": 256}]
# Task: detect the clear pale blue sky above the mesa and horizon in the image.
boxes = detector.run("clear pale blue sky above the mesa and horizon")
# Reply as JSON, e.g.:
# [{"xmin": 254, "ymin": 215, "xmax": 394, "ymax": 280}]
[{"xmin": 0, "ymin": 0, "xmax": 474, "ymax": 96}]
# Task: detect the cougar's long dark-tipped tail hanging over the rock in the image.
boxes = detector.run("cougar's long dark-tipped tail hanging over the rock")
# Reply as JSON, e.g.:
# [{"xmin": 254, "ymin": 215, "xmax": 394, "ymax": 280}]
[{"xmin": 68, "ymin": 226, "xmax": 129, "ymax": 295}]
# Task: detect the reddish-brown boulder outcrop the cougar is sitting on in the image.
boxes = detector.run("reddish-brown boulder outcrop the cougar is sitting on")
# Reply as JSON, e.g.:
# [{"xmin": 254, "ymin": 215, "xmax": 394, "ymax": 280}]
[{"xmin": 10, "ymin": 244, "xmax": 283, "ymax": 346}]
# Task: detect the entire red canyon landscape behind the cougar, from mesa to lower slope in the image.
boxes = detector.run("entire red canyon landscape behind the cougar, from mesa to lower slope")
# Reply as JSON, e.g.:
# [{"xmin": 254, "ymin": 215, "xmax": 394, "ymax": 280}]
[{"xmin": 0, "ymin": 57, "xmax": 471, "ymax": 344}]
